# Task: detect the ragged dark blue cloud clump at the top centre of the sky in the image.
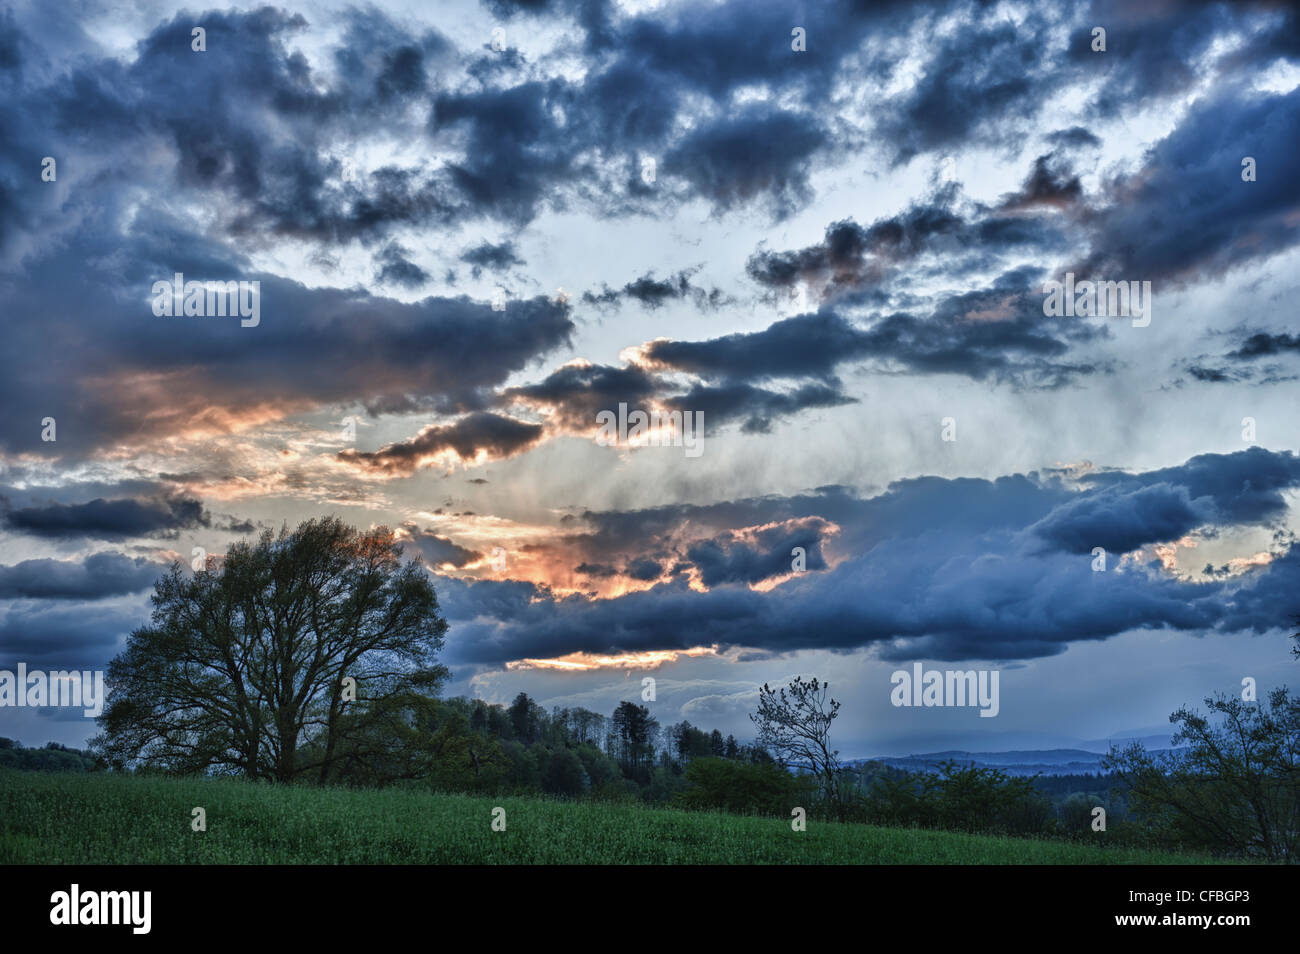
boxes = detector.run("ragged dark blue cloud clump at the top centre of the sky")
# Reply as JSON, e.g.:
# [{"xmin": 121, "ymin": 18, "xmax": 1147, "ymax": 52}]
[{"xmin": 430, "ymin": 0, "xmax": 1041, "ymax": 222}]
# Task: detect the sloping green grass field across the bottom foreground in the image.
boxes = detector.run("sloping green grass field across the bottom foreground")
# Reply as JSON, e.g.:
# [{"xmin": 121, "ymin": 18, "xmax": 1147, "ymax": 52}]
[{"xmin": 0, "ymin": 769, "xmax": 1237, "ymax": 864}]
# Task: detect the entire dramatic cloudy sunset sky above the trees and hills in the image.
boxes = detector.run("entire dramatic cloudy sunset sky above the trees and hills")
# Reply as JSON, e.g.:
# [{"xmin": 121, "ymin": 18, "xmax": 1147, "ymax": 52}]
[{"xmin": 0, "ymin": 0, "xmax": 1300, "ymax": 755}]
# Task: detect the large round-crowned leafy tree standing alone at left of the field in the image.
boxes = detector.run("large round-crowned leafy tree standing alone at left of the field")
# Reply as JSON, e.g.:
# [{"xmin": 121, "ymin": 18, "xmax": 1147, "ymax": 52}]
[{"xmin": 96, "ymin": 517, "xmax": 447, "ymax": 784}]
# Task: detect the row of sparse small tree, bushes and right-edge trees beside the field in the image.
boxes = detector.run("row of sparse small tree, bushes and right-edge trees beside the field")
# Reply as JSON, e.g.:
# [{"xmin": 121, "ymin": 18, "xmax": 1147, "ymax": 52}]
[{"xmin": 753, "ymin": 675, "xmax": 1300, "ymax": 863}]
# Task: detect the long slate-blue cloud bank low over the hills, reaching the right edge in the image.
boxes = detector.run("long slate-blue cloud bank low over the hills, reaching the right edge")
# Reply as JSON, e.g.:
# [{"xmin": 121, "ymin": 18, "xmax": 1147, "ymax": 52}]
[{"xmin": 439, "ymin": 448, "xmax": 1300, "ymax": 665}]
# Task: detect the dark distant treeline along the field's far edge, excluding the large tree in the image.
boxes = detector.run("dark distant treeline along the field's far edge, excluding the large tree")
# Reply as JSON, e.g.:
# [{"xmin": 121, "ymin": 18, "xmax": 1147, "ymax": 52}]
[{"xmin": 0, "ymin": 712, "xmax": 1125, "ymax": 836}]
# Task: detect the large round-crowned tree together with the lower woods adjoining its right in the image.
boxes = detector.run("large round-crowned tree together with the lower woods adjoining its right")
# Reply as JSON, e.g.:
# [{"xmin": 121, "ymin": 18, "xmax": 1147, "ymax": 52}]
[{"xmin": 94, "ymin": 517, "xmax": 767, "ymax": 794}]
